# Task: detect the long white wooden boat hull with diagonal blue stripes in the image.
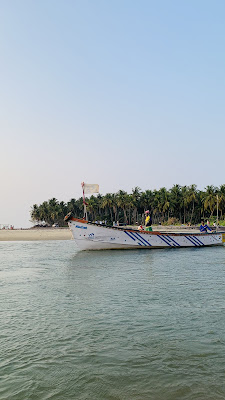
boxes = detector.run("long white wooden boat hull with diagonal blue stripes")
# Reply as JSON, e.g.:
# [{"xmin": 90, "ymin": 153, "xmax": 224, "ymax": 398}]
[{"xmin": 65, "ymin": 214, "xmax": 225, "ymax": 250}]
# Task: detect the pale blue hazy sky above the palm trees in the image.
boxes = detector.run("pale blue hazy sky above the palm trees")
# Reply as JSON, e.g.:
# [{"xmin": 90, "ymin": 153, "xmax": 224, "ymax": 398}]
[{"xmin": 0, "ymin": 0, "xmax": 225, "ymax": 228}]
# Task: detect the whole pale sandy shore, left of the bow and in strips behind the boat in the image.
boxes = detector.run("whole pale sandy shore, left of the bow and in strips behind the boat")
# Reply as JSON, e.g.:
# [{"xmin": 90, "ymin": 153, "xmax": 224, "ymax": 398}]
[{"xmin": 0, "ymin": 225, "xmax": 206, "ymax": 241}]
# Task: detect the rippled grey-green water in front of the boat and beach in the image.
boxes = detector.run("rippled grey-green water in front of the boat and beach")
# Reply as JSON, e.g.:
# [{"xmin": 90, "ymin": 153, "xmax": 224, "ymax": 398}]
[{"xmin": 0, "ymin": 241, "xmax": 225, "ymax": 400}]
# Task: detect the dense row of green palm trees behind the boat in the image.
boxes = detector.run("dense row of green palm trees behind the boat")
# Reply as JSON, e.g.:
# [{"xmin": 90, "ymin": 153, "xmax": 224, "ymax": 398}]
[{"xmin": 30, "ymin": 184, "xmax": 225, "ymax": 226}]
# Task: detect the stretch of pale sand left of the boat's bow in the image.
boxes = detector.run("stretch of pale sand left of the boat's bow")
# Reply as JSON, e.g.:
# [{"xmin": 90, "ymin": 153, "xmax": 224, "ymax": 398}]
[{"xmin": 0, "ymin": 228, "xmax": 72, "ymax": 241}]
